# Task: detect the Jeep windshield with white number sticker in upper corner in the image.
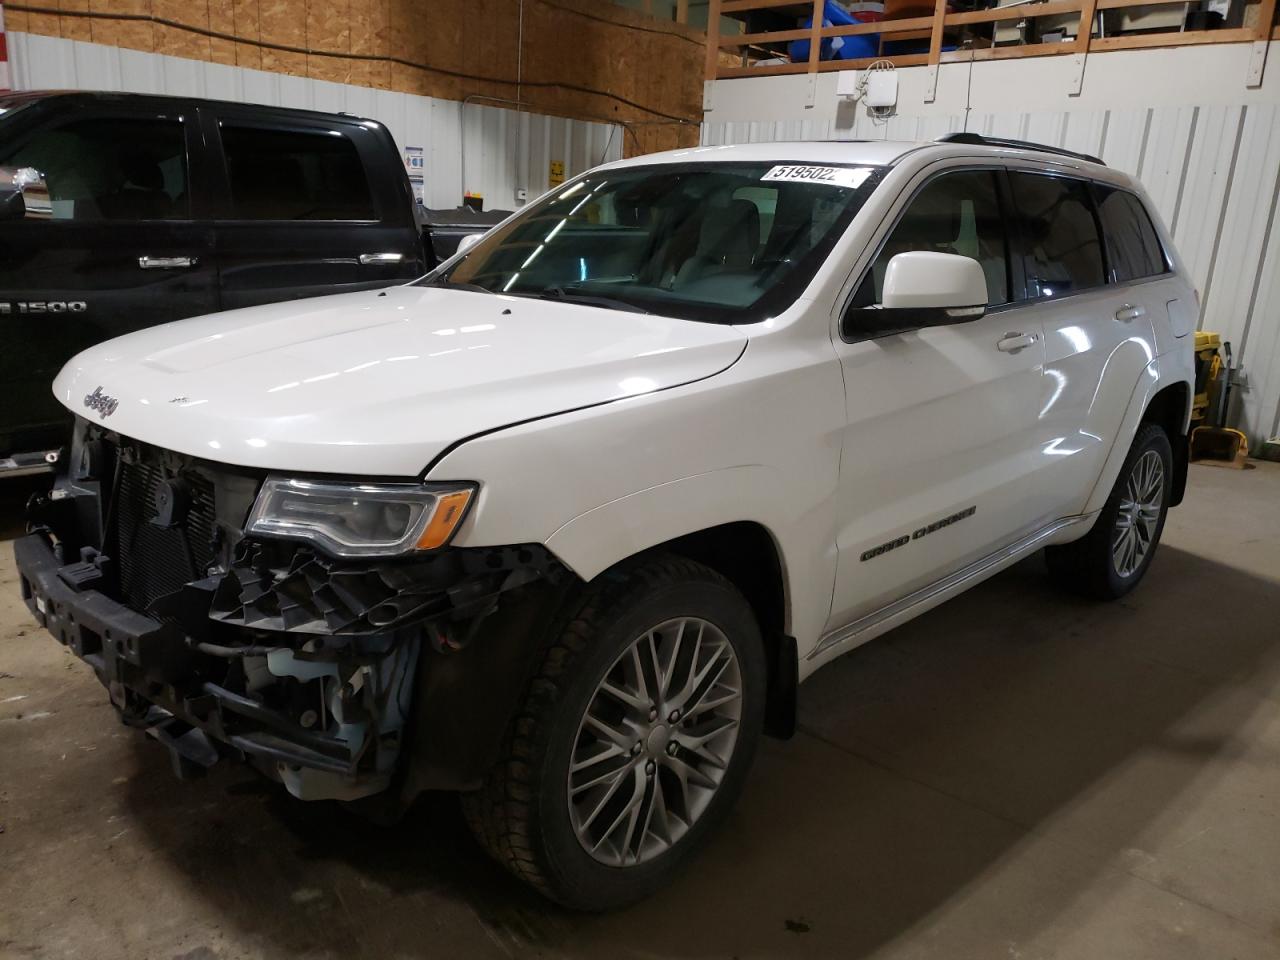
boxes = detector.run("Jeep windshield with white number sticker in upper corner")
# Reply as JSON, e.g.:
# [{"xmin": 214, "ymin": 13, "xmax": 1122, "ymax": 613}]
[{"xmin": 420, "ymin": 163, "xmax": 883, "ymax": 324}]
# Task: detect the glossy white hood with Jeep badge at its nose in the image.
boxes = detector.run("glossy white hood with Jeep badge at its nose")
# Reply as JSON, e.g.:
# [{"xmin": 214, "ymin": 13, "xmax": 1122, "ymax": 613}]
[{"xmin": 54, "ymin": 287, "xmax": 746, "ymax": 479}]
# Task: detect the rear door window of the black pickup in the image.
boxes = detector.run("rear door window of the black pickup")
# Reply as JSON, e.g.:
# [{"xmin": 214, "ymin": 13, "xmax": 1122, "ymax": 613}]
[{"xmin": 221, "ymin": 122, "xmax": 378, "ymax": 220}]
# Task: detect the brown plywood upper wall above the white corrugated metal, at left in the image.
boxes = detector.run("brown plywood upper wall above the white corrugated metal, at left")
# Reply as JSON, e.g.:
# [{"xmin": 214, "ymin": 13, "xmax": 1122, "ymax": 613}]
[{"xmin": 9, "ymin": 0, "xmax": 705, "ymax": 154}]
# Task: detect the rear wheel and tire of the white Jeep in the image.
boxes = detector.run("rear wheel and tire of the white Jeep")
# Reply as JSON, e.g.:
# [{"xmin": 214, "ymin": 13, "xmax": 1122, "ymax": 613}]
[{"xmin": 1044, "ymin": 424, "xmax": 1174, "ymax": 600}]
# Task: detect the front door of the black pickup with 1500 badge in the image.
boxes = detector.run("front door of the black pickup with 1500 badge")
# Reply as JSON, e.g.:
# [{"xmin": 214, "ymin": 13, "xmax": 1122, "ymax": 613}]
[{"xmin": 0, "ymin": 97, "xmax": 218, "ymax": 456}]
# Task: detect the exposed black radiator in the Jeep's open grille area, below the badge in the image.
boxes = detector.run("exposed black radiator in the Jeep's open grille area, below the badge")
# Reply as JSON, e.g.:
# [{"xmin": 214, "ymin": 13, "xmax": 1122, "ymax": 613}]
[{"xmin": 115, "ymin": 458, "xmax": 215, "ymax": 612}]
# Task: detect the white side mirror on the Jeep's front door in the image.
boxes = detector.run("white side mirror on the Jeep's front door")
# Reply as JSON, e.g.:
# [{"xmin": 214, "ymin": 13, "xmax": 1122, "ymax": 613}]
[{"xmin": 842, "ymin": 250, "xmax": 987, "ymax": 339}]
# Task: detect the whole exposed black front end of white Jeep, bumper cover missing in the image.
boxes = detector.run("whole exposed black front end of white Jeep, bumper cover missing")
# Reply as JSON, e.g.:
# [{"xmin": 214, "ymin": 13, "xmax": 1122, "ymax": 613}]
[{"xmin": 14, "ymin": 425, "xmax": 566, "ymax": 808}]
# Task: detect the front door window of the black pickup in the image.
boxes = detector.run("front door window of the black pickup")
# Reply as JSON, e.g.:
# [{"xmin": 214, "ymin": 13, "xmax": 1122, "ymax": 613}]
[{"xmin": 0, "ymin": 116, "xmax": 189, "ymax": 220}]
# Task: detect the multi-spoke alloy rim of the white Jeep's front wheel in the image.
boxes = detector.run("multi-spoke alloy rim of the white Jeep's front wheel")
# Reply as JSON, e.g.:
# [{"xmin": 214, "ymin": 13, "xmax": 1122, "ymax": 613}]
[{"xmin": 568, "ymin": 617, "xmax": 742, "ymax": 867}]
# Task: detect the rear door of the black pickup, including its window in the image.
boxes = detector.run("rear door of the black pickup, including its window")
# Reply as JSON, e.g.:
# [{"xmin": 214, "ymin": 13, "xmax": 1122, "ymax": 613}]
[{"xmin": 201, "ymin": 105, "xmax": 425, "ymax": 308}]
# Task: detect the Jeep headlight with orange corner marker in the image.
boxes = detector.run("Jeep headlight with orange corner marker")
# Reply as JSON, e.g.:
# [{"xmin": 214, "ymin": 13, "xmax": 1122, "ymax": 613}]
[{"xmin": 246, "ymin": 477, "xmax": 475, "ymax": 557}]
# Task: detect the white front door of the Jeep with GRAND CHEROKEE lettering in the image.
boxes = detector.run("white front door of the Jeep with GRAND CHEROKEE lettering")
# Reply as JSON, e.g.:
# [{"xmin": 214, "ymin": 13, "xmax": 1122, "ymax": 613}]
[{"xmin": 828, "ymin": 169, "xmax": 1044, "ymax": 631}]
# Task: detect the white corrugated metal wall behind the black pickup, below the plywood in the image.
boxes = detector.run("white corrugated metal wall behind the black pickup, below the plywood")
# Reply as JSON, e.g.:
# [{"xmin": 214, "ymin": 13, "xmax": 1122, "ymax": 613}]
[{"xmin": 9, "ymin": 33, "xmax": 622, "ymax": 209}]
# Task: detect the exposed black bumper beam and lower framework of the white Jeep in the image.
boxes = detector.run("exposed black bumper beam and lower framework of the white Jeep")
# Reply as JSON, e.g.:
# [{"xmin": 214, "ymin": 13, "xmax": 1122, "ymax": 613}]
[{"xmin": 14, "ymin": 534, "xmax": 419, "ymax": 800}]
